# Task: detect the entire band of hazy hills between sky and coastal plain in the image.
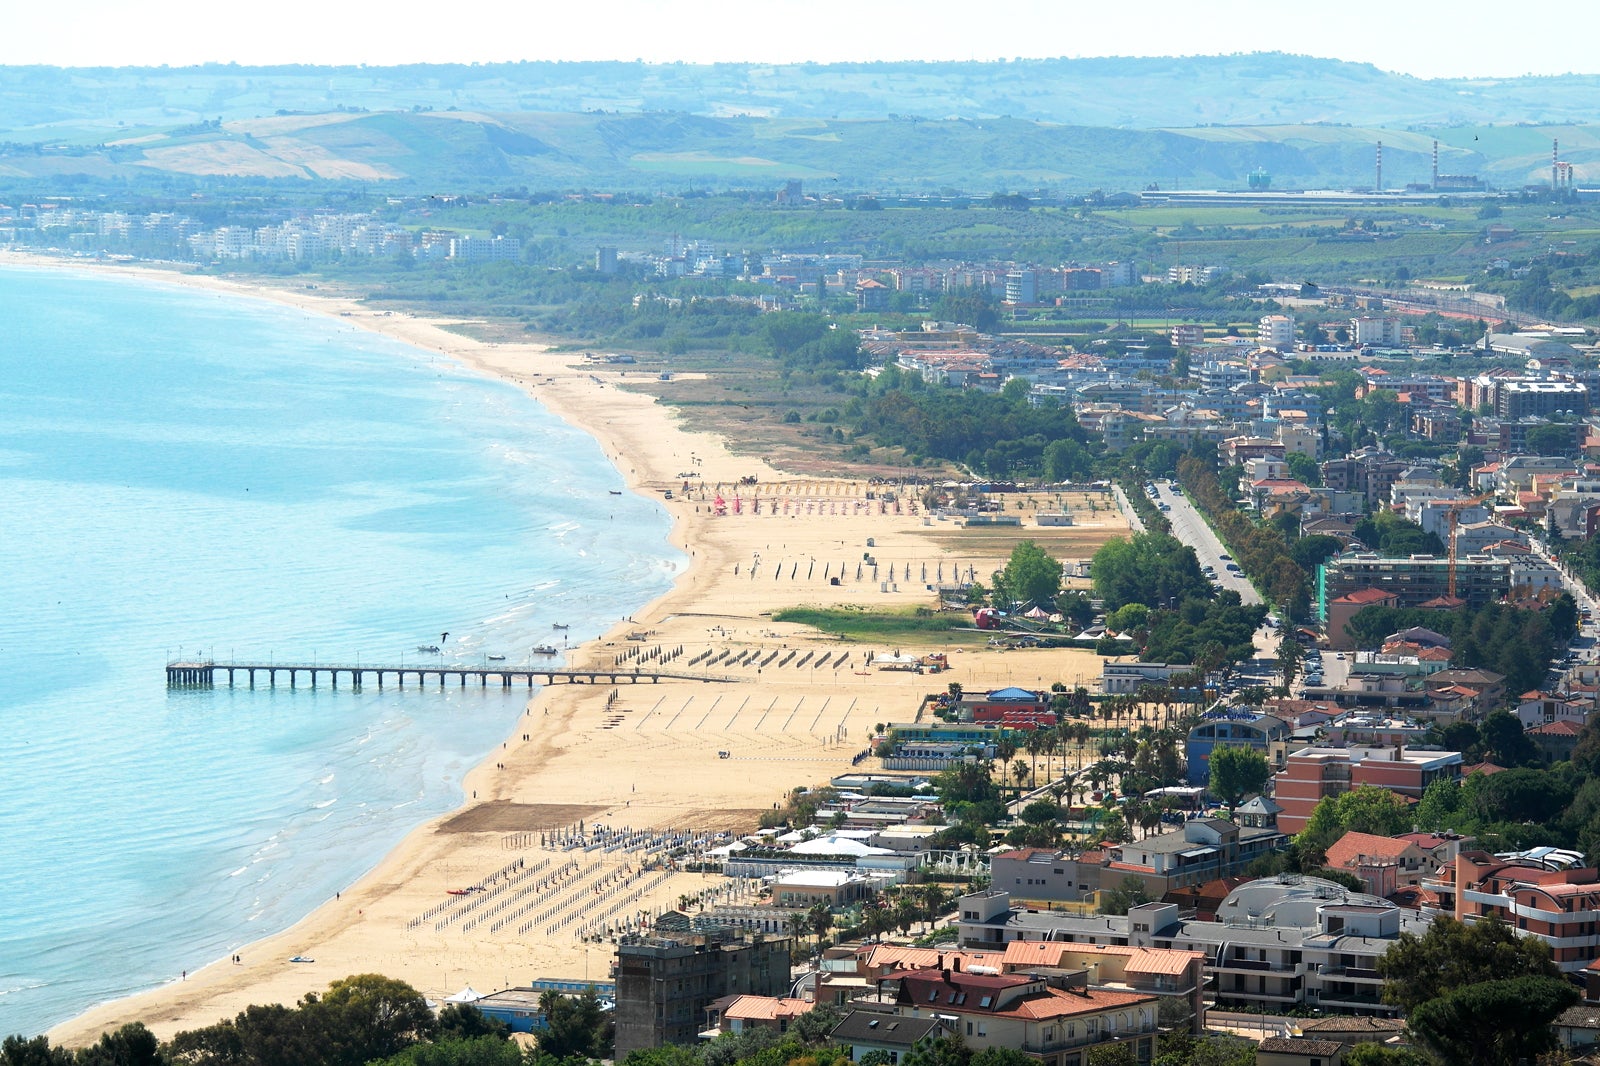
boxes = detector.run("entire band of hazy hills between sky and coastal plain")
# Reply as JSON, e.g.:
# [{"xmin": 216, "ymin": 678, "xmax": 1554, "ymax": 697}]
[{"xmin": 0, "ymin": 53, "xmax": 1600, "ymax": 194}]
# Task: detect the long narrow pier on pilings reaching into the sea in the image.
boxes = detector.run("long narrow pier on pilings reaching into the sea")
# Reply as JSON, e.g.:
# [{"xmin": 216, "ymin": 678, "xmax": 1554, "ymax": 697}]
[{"xmin": 166, "ymin": 661, "xmax": 741, "ymax": 691}]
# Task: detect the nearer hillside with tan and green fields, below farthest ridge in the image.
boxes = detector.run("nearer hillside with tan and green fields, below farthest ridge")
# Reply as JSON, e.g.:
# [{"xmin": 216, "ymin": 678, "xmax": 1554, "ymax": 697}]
[{"xmin": 0, "ymin": 110, "xmax": 1536, "ymax": 195}]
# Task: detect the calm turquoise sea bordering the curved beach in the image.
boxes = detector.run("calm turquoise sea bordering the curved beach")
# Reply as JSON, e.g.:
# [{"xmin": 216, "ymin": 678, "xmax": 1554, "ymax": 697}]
[{"xmin": 0, "ymin": 266, "xmax": 685, "ymax": 1036}]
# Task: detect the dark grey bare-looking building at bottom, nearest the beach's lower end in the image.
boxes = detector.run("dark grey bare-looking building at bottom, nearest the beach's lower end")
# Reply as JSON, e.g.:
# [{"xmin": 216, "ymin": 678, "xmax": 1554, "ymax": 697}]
[{"xmin": 616, "ymin": 932, "xmax": 792, "ymax": 1060}]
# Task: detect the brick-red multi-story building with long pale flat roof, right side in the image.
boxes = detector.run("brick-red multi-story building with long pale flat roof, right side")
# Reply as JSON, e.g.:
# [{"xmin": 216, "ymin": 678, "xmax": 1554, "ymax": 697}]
[{"xmin": 1272, "ymin": 744, "xmax": 1461, "ymax": 834}]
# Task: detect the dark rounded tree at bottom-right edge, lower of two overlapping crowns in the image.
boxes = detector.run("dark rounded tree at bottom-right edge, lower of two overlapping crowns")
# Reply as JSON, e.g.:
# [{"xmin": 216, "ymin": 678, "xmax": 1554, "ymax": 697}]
[{"xmin": 1406, "ymin": 976, "xmax": 1579, "ymax": 1066}]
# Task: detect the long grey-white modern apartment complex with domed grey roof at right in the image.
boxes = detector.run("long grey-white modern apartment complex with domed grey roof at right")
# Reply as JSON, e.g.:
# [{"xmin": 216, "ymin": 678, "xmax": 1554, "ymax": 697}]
[{"xmin": 958, "ymin": 874, "xmax": 1427, "ymax": 1013}]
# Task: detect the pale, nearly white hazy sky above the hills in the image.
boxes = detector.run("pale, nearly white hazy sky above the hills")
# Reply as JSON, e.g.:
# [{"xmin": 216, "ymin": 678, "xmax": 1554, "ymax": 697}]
[{"xmin": 12, "ymin": 0, "xmax": 1600, "ymax": 77}]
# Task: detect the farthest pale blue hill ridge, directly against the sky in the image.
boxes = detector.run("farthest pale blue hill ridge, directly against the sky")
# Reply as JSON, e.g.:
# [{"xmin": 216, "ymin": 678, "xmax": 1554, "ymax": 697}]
[{"xmin": 9, "ymin": 53, "xmax": 1600, "ymax": 132}]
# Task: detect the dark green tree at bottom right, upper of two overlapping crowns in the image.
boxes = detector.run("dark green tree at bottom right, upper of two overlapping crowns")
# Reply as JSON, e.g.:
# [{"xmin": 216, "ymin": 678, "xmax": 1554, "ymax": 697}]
[{"xmin": 1378, "ymin": 917, "xmax": 1560, "ymax": 1016}]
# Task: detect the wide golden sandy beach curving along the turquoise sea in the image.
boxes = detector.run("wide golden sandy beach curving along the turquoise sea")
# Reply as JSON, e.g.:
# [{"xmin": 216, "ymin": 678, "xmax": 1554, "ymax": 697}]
[{"xmin": 21, "ymin": 256, "xmax": 1125, "ymax": 1045}]
